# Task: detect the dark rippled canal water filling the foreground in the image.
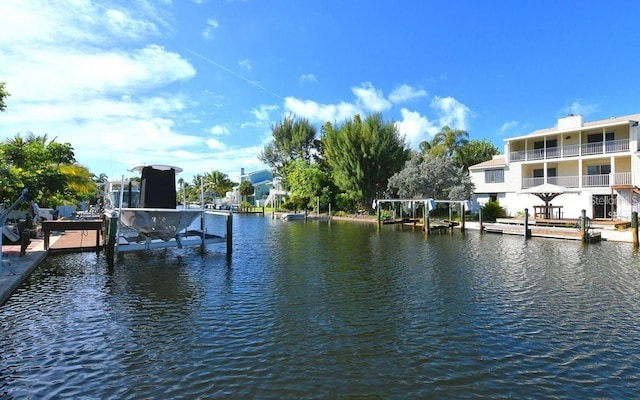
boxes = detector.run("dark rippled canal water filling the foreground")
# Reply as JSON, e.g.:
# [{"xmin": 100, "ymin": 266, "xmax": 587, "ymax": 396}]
[{"xmin": 0, "ymin": 215, "xmax": 640, "ymax": 399}]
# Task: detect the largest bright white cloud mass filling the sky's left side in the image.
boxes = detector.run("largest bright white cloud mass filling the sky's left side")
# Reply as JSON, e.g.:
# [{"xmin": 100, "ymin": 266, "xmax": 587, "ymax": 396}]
[{"xmin": 0, "ymin": 0, "xmax": 204, "ymax": 177}]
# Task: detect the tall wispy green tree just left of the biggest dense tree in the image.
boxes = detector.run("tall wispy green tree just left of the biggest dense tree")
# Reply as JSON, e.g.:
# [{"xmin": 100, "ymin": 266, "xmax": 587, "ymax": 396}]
[{"xmin": 258, "ymin": 116, "xmax": 317, "ymax": 176}]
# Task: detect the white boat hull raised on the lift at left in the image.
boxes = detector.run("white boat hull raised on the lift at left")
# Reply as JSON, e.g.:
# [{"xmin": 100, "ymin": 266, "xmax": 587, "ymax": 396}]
[{"xmin": 120, "ymin": 208, "xmax": 203, "ymax": 241}]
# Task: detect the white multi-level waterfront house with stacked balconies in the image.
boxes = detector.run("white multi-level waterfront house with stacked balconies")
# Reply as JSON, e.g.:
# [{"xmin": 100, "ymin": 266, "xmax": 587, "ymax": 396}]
[{"xmin": 469, "ymin": 114, "xmax": 640, "ymax": 220}]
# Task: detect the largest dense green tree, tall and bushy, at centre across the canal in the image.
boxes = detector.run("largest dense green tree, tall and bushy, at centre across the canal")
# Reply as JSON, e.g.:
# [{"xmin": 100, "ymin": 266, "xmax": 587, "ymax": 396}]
[{"xmin": 322, "ymin": 113, "xmax": 410, "ymax": 209}]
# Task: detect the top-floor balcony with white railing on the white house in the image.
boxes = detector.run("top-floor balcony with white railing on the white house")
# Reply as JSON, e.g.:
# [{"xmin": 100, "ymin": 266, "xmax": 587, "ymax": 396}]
[{"xmin": 509, "ymin": 139, "xmax": 629, "ymax": 162}]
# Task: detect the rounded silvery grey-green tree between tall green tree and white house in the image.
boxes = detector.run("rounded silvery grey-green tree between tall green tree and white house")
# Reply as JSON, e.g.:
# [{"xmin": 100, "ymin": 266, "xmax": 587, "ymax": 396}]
[{"xmin": 388, "ymin": 155, "xmax": 473, "ymax": 200}]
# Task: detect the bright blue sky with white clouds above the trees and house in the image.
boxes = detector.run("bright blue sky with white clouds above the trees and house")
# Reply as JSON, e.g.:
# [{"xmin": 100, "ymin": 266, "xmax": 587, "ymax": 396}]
[{"xmin": 0, "ymin": 0, "xmax": 640, "ymax": 182}]
